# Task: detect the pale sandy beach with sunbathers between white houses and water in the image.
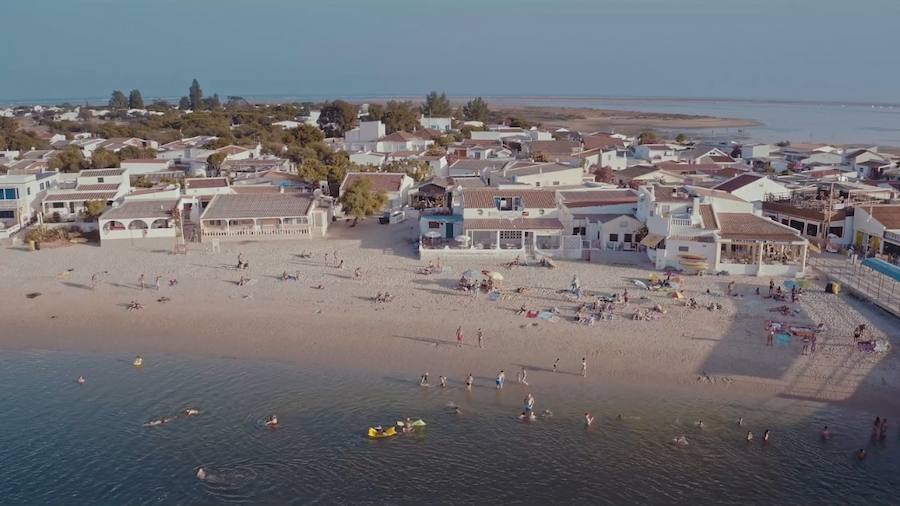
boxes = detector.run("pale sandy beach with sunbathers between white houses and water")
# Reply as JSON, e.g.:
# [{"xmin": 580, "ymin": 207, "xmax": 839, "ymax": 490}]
[{"xmin": 0, "ymin": 220, "xmax": 900, "ymax": 416}]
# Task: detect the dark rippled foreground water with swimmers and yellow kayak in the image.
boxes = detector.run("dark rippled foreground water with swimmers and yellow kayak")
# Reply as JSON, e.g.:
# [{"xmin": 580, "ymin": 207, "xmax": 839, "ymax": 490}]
[{"xmin": 0, "ymin": 352, "xmax": 900, "ymax": 505}]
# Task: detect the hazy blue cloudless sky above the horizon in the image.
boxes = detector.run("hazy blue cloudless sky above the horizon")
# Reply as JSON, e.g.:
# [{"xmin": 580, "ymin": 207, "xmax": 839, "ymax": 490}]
[{"xmin": 0, "ymin": 0, "xmax": 900, "ymax": 102}]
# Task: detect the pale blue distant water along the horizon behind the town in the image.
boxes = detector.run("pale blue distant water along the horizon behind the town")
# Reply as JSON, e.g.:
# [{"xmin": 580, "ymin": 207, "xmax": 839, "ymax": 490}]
[{"xmin": 10, "ymin": 95, "xmax": 900, "ymax": 147}]
